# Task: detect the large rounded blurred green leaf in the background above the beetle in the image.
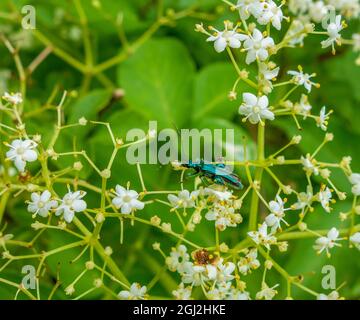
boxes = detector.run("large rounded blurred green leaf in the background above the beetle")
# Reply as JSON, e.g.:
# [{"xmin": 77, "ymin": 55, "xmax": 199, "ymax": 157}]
[{"xmin": 118, "ymin": 39, "xmax": 194, "ymax": 127}]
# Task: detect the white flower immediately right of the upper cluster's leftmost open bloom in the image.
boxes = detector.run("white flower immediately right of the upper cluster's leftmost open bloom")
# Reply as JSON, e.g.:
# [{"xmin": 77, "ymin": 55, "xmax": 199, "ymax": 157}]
[{"xmin": 244, "ymin": 29, "xmax": 275, "ymax": 64}]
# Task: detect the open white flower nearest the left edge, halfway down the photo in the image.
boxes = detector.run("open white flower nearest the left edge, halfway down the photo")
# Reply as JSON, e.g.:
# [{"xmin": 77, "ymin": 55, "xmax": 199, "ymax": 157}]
[{"xmin": 6, "ymin": 139, "xmax": 38, "ymax": 172}]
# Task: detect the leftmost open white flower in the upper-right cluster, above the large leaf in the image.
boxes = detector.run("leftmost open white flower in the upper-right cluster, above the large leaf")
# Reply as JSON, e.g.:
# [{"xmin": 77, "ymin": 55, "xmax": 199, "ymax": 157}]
[{"xmin": 207, "ymin": 23, "xmax": 247, "ymax": 53}]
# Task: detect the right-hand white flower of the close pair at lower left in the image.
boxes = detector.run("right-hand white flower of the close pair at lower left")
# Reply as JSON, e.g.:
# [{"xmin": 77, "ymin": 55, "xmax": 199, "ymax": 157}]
[{"xmin": 55, "ymin": 189, "xmax": 86, "ymax": 223}]
